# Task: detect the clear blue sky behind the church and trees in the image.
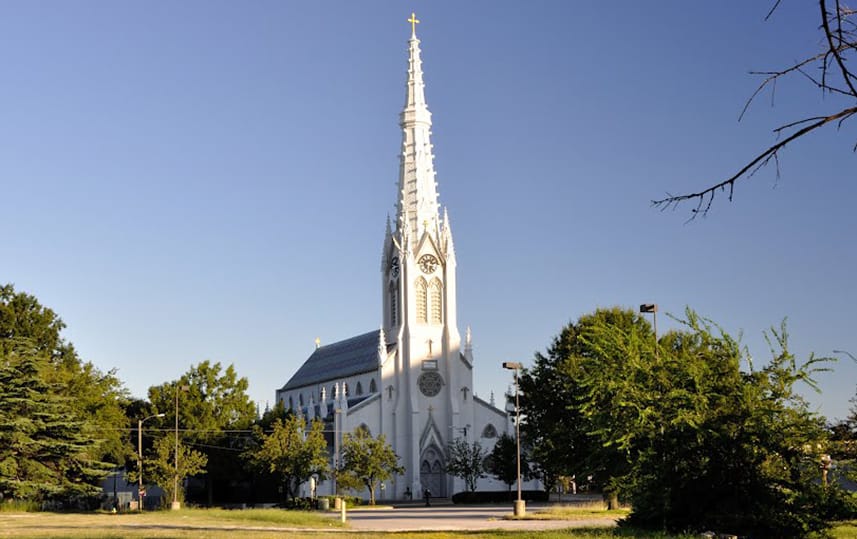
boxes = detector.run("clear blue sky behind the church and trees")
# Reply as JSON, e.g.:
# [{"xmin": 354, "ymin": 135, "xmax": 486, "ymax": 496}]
[{"xmin": 0, "ymin": 0, "xmax": 857, "ymax": 418}]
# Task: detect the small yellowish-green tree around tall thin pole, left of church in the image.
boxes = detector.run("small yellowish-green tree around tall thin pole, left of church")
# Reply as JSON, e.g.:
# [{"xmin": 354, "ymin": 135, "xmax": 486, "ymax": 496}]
[{"xmin": 145, "ymin": 432, "xmax": 208, "ymax": 503}]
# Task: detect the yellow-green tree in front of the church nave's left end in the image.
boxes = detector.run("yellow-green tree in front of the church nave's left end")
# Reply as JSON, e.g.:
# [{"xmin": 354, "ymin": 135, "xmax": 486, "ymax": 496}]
[{"xmin": 245, "ymin": 415, "xmax": 330, "ymax": 499}]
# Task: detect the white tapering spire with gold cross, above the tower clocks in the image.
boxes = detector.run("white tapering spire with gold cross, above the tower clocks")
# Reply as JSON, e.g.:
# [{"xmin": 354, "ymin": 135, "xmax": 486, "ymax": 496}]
[{"xmin": 397, "ymin": 13, "xmax": 439, "ymax": 240}]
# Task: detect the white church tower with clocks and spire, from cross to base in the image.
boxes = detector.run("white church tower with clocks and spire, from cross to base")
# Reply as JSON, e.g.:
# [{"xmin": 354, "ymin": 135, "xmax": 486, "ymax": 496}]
[{"xmin": 381, "ymin": 14, "xmax": 473, "ymax": 496}]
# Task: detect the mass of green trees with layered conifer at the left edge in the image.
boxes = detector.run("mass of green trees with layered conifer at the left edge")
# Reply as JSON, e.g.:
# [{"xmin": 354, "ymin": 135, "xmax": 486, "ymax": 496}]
[{"xmin": 0, "ymin": 285, "xmax": 131, "ymax": 501}]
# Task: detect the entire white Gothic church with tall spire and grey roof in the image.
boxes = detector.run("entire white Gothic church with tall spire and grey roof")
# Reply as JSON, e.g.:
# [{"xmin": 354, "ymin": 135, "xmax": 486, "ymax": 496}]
[{"xmin": 276, "ymin": 17, "xmax": 513, "ymax": 498}]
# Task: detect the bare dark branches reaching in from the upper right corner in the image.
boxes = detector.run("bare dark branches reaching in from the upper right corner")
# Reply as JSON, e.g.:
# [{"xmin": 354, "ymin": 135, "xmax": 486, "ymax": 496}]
[{"xmin": 652, "ymin": 0, "xmax": 857, "ymax": 218}]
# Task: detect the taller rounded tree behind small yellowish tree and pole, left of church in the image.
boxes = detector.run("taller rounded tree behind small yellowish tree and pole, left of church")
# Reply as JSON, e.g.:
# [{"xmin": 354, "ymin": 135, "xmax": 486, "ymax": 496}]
[{"xmin": 149, "ymin": 361, "xmax": 256, "ymax": 504}]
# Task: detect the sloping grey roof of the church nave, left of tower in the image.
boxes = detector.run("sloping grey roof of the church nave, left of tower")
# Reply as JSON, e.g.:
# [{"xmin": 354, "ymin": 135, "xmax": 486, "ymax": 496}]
[{"xmin": 280, "ymin": 329, "xmax": 384, "ymax": 397}]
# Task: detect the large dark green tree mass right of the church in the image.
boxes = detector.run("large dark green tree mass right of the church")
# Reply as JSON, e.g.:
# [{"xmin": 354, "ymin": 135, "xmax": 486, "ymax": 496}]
[{"xmin": 522, "ymin": 309, "xmax": 838, "ymax": 537}]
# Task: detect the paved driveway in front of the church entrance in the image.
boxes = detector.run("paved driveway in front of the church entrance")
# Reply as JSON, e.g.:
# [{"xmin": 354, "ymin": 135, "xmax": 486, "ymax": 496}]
[{"xmin": 347, "ymin": 505, "xmax": 615, "ymax": 531}]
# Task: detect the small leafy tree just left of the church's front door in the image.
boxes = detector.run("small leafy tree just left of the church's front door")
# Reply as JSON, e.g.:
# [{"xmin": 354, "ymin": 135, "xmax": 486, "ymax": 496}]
[{"xmin": 337, "ymin": 428, "xmax": 405, "ymax": 505}]
